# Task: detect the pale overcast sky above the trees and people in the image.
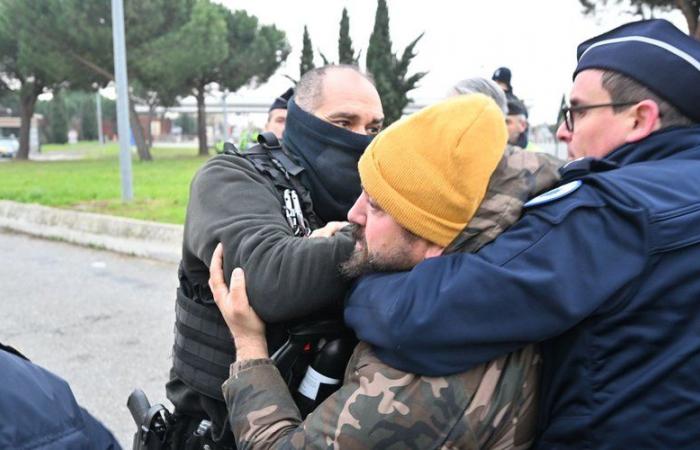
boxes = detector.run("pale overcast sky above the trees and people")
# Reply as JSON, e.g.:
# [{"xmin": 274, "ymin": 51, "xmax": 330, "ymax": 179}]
[{"xmin": 221, "ymin": 0, "xmax": 687, "ymax": 124}]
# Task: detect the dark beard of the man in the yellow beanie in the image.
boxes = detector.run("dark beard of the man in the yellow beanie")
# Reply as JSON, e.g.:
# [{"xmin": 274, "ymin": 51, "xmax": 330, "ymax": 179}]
[{"xmin": 340, "ymin": 224, "xmax": 420, "ymax": 279}]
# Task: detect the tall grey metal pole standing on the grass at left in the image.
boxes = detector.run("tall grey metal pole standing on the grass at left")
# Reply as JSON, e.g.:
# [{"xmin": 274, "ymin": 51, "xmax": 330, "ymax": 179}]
[{"xmin": 112, "ymin": 0, "xmax": 134, "ymax": 202}]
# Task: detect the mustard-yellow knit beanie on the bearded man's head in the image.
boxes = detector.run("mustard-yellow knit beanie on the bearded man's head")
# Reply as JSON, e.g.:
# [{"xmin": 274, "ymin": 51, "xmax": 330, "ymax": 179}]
[{"xmin": 359, "ymin": 94, "xmax": 508, "ymax": 247}]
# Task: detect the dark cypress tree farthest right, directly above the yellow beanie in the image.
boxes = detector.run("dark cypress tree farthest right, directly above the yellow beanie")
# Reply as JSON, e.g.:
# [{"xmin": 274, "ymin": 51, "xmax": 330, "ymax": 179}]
[{"xmin": 366, "ymin": 0, "xmax": 426, "ymax": 125}]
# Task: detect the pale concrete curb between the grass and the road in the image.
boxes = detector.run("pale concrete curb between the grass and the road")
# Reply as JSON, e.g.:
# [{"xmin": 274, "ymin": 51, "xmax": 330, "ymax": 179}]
[{"xmin": 0, "ymin": 200, "xmax": 184, "ymax": 263}]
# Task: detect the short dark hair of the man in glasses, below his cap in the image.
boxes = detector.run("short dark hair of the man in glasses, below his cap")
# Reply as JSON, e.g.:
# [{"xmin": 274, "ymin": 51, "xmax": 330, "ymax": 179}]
[{"xmin": 603, "ymin": 70, "xmax": 695, "ymax": 128}]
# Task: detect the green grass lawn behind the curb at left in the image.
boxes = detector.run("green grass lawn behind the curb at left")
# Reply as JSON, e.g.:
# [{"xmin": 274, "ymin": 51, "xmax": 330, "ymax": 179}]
[{"xmin": 0, "ymin": 142, "xmax": 207, "ymax": 224}]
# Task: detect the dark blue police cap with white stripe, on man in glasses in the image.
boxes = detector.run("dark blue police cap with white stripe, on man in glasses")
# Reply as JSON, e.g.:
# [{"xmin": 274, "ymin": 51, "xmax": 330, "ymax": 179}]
[{"xmin": 574, "ymin": 19, "xmax": 700, "ymax": 122}]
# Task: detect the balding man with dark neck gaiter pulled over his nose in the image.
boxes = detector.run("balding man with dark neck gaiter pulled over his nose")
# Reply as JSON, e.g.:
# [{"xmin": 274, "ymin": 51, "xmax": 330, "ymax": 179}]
[{"xmin": 166, "ymin": 66, "xmax": 383, "ymax": 449}]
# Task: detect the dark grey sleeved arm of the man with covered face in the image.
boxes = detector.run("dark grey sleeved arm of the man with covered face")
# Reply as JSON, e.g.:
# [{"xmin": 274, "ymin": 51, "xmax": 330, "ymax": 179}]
[{"xmin": 183, "ymin": 159, "xmax": 353, "ymax": 323}]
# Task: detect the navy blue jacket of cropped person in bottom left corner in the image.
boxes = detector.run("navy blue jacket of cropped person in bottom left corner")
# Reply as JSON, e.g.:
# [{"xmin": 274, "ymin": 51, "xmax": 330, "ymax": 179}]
[{"xmin": 0, "ymin": 348, "xmax": 121, "ymax": 450}]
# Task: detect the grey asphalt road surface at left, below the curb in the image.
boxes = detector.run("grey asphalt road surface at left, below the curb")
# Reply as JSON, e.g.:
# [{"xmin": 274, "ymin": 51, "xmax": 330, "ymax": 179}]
[{"xmin": 0, "ymin": 230, "xmax": 177, "ymax": 449}]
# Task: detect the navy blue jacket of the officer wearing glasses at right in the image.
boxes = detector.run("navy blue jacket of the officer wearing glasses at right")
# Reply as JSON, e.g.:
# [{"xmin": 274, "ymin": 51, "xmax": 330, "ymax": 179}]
[{"xmin": 345, "ymin": 126, "xmax": 700, "ymax": 449}]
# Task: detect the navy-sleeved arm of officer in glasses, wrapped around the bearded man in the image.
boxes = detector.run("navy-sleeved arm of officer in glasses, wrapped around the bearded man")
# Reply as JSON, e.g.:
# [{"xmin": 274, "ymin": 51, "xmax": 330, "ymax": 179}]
[{"xmin": 345, "ymin": 208, "xmax": 646, "ymax": 375}]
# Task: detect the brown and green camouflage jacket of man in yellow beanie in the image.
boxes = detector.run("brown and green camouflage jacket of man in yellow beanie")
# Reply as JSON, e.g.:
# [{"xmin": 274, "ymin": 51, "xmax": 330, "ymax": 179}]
[{"xmin": 223, "ymin": 148, "xmax": 561, "ymax": 450}]
